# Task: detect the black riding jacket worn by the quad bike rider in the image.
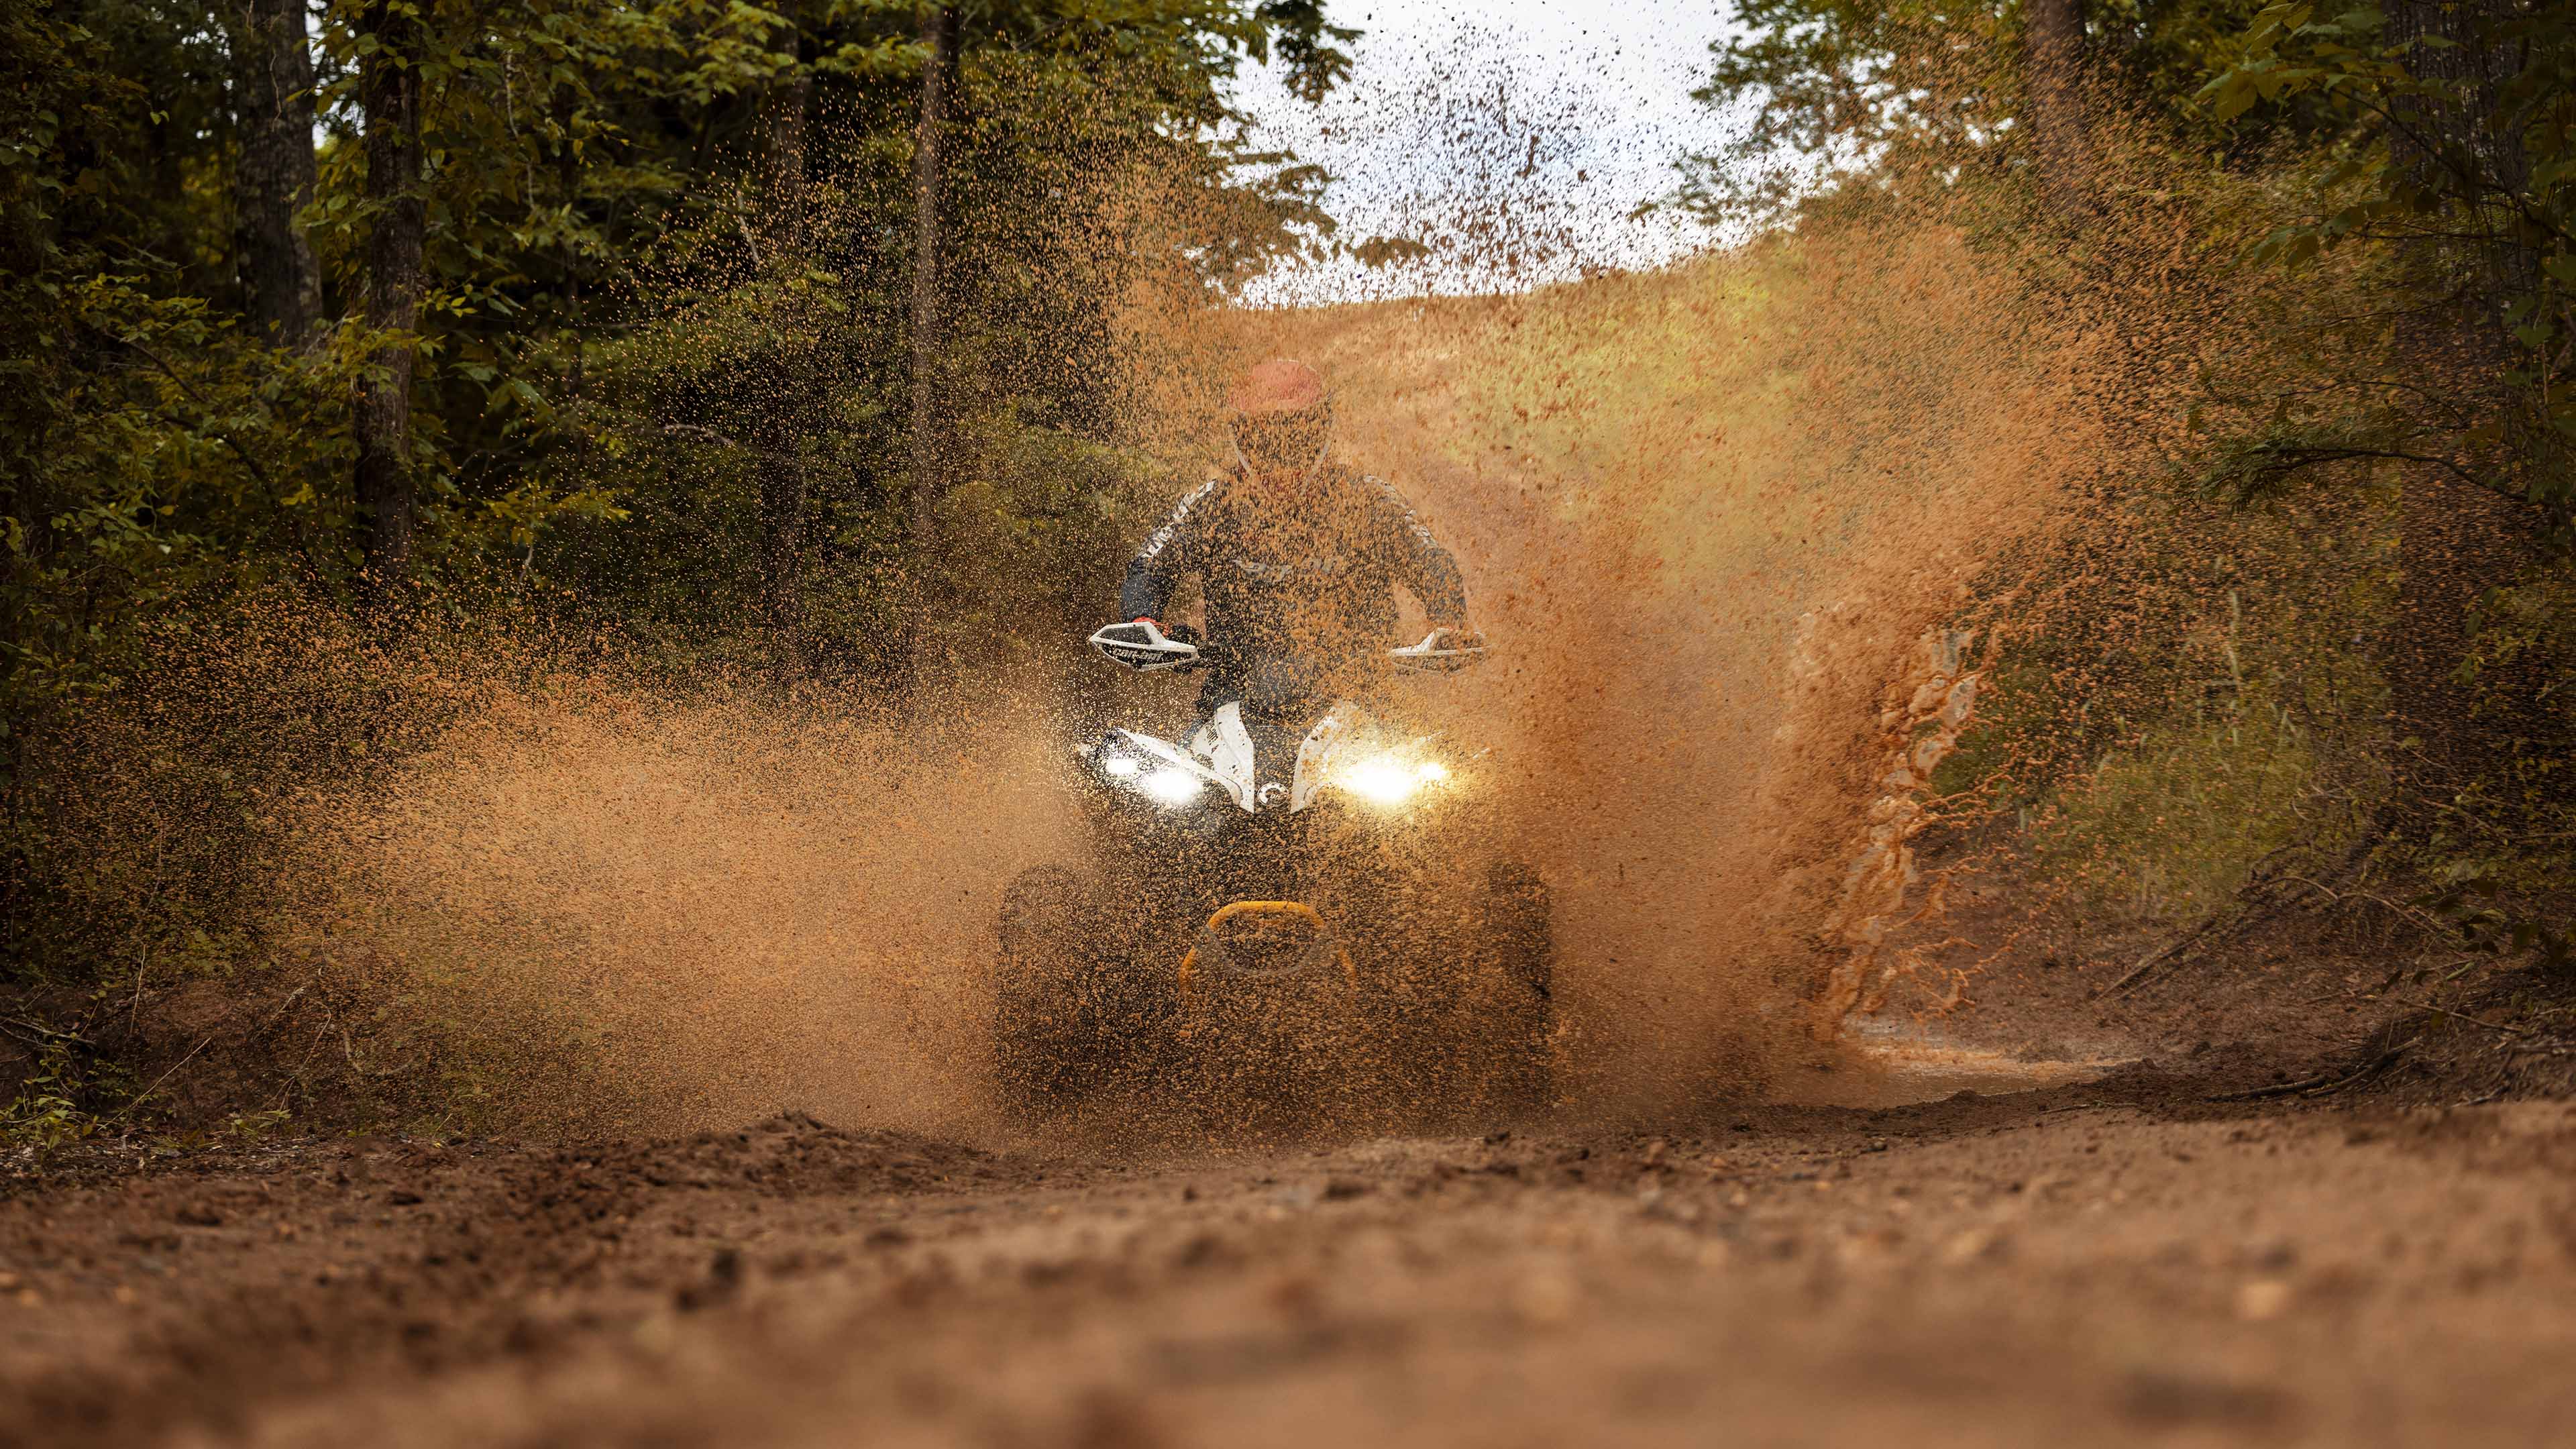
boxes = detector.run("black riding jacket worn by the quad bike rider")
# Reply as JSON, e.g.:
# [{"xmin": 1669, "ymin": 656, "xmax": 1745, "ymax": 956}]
[{"xmin": 1118, "ymin": 462, "xmax": 1466, "ymax": 676}]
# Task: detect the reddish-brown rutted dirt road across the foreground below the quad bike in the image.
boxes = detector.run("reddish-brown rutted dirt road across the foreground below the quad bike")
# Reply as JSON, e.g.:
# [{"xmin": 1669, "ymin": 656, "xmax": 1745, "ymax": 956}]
[{"xmin": 0, "ymin": 1075, "xmax": 2576, "ymax": 1446}]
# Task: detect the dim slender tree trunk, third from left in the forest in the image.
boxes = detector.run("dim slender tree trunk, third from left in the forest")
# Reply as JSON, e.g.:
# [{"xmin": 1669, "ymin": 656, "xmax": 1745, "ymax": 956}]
[{"xmin": 755, "ymin": 74, "xmax": 814, "ymax": 684}]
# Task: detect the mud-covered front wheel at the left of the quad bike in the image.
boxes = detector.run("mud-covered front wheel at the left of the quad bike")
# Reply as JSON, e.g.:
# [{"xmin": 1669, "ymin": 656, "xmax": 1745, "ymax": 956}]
[{"xmin": 991, "ymin": 866, "xmax": 1097, "ymax": 1116}]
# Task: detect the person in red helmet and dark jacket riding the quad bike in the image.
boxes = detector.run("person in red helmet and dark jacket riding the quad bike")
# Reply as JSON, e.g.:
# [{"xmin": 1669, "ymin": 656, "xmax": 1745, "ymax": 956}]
[{"xmin": 1118, "ymin": 358, "xmax": 1479, "ymax": 706}]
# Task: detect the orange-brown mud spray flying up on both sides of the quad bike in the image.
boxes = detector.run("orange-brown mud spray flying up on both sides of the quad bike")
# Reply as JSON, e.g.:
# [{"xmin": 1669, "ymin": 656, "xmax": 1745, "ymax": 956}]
[{"xmin": 266, "ymin": 50, "xmax": 2153, "ymax": 1137}]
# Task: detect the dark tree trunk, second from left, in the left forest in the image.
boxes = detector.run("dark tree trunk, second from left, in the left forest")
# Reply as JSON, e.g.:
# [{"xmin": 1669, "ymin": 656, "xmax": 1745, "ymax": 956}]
[{"xmin": 350, "ymin": 0, "xmax": 427, "ymax": 596}]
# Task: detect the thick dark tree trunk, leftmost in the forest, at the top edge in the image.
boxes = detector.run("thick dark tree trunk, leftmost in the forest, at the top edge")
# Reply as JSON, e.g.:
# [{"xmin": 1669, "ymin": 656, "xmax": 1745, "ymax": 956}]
[{"xmin": 224, "ymin": 0, "xmax": 322, "ymax": 348}]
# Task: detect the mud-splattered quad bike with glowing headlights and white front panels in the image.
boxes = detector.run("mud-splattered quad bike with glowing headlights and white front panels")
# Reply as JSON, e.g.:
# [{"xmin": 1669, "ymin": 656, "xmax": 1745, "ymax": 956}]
[{"xmin": 994, "ymin": 621, "xmax": 1554, "ymax": 1132}]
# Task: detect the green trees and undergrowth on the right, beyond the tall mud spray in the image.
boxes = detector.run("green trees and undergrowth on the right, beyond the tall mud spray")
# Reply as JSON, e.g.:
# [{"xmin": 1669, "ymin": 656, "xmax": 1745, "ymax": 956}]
[{"xmin": 1680, "ymin": 0, "xmax": 2576, "ymax": 969}]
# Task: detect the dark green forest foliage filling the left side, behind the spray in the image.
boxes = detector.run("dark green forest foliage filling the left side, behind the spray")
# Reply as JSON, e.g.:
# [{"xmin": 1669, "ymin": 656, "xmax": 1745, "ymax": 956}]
[{"xmin": 0, "ymin": 0, "xmax": 1352, "ymax": 1046}]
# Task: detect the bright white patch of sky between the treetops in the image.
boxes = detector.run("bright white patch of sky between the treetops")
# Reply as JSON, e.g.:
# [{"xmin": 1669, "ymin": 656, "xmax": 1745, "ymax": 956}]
[{"xmin": 1236, "ymin": 0, "xmax": 1741, "ymax": 305}]
